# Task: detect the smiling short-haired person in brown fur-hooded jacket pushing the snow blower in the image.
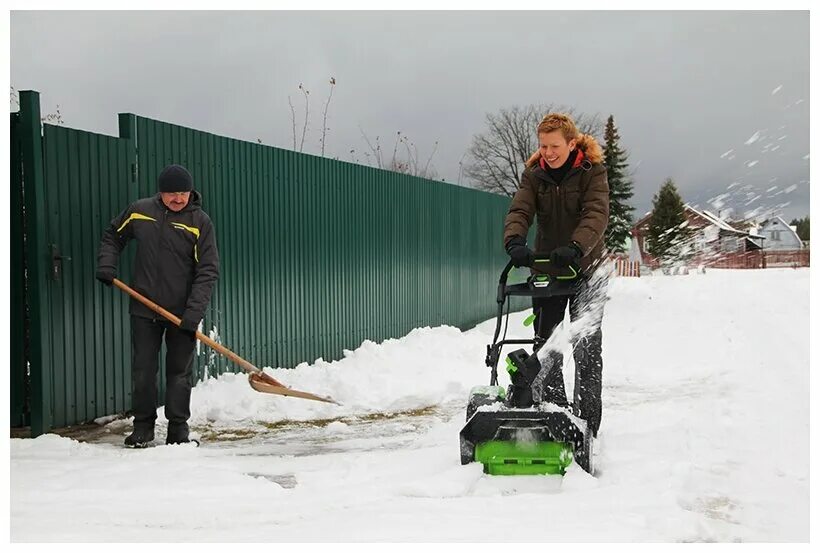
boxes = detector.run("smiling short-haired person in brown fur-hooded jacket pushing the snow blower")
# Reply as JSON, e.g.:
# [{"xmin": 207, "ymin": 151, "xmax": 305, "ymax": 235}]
[{"xmin": 504, "ymin": 113, "xmax": 609, "ymax": 436}]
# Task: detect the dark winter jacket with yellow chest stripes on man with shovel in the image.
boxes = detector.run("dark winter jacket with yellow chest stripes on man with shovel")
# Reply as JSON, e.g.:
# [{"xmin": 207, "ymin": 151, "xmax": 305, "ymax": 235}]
[{"xmin": 97, "ymin": 190, "xmax": 219, "ymax": 323}]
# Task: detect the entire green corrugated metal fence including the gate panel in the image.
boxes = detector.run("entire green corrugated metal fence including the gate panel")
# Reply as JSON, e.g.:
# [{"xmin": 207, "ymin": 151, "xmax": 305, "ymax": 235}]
[{"xmin": 14, "ymin": 92, "xmax": 524, "ymax": 433}]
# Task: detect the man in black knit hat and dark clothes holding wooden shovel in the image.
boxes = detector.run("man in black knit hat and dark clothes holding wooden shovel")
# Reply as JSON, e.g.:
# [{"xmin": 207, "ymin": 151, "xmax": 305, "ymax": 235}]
[{"xmin": 96, "ymin": 165, "xmax": 219, "ymax": 447}]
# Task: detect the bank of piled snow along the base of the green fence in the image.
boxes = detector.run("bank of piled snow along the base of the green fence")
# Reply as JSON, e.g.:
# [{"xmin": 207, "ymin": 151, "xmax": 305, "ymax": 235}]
[{"xmin": 187, "ymin": 322, "xmax": 502, "ymax": 426}]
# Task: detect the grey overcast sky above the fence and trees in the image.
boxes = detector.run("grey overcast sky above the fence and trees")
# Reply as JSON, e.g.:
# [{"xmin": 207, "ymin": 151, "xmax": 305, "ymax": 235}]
[{"xmin": 11, "ymin": 11, "xmax": 810, "ymax": 220}]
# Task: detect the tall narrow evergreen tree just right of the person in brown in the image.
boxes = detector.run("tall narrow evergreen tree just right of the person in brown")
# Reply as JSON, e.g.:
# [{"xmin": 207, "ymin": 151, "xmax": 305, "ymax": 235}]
[{"xmin": 604, "ymin": 115, "xmax": 635, "ymax": 253}]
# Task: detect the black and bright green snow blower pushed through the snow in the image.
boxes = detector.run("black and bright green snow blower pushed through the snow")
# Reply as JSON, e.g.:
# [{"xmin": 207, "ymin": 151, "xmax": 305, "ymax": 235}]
[{"xmin": 460, "ymin": 253, "xmax": 592, "ymax": 475}]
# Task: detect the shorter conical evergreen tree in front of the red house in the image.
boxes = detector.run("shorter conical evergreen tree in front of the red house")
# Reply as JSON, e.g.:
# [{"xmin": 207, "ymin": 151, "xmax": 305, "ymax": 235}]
[{"xmin": 646, "ymin": 178, "xmax": 691, "ymax": 265}]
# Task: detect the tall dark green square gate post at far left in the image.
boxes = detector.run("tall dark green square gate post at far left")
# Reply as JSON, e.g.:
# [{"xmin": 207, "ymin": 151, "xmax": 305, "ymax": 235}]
[{"xmin": 20, "ymin": 90, "xmax": 52, "ymax": 437}]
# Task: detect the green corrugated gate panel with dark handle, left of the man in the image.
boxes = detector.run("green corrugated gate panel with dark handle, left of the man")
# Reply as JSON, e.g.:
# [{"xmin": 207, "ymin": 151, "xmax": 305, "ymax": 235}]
[{"xmin": 43, "ymin": 125, "xmax": 136, "ymax": 427}]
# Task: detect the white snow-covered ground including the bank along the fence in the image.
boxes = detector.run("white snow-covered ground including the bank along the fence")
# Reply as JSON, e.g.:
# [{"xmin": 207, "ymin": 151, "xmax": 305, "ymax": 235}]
[{"xmin": 11, "ymin": 269, "xmax": 809, "ymax": 542}]
